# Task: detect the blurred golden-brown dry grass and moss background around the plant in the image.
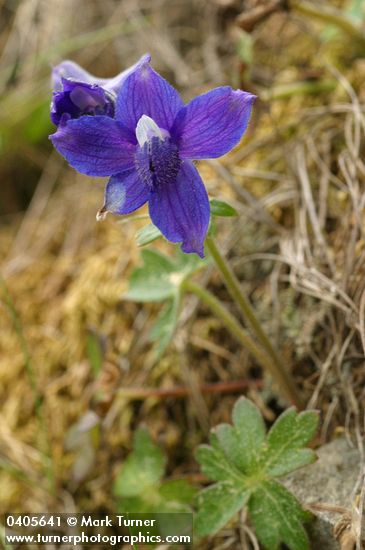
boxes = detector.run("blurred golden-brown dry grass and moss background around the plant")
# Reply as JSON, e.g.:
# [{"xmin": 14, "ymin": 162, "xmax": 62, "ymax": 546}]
[{"xmin": 0, "ymin": 0, "xmax": 365, "ymax": 548}]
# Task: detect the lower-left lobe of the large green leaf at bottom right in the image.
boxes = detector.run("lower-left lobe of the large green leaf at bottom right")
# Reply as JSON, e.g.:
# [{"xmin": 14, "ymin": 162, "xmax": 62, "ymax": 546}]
[{"xmin": 194, "ymin": 481, "xmax": 250, "ymax": 537}]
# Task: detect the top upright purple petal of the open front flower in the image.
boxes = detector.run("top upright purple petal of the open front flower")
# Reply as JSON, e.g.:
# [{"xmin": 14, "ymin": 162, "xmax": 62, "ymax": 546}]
[{"xmin": 116, "ymin": 62, "xmax": 184, "ymax": 131}]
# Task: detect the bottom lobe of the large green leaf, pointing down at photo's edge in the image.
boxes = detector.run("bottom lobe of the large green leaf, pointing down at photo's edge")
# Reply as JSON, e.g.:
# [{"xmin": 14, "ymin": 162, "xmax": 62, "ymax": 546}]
[{"xmin": 248, "ymin": 481, "xmax": 310, "ymax": 550}]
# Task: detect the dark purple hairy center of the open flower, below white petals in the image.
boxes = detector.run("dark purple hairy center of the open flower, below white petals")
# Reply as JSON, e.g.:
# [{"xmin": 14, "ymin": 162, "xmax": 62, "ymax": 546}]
[{"xmin": 135, "ymin": 137, "xmax": 181, "ymax": 191}]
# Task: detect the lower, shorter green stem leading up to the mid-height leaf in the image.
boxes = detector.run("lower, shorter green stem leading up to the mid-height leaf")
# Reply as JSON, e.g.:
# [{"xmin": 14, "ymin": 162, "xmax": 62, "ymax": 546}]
[{"xmin": 182, "ymin": 279, "xmax": 303, "ymax": 408}]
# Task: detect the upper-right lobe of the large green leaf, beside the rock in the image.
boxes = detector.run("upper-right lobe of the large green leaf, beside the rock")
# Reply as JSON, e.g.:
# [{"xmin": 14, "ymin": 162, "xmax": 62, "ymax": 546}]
[{"xmin": 264, "ymin": 409, "xmax": 319, "ymax": 476}]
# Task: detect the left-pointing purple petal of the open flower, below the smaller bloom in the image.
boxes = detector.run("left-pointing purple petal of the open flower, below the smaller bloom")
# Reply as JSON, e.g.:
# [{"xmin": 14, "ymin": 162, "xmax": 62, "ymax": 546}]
[{"xmin": 50, "ymin": 116, "xmax": 137, "ymax": 176}]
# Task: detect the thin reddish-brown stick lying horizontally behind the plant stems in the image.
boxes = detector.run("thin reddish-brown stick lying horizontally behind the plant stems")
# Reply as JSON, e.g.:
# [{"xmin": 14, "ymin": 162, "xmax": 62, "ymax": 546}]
[{"xmin": 118, "ymin": 379, "xmax": 263, "ymax": 401}]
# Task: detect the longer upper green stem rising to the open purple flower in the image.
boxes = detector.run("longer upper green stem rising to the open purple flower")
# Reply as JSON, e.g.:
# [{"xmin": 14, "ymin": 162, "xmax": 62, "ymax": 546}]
[{"xmin": 206, "ymin": 237, "xmax": 303, "ymax": 409}]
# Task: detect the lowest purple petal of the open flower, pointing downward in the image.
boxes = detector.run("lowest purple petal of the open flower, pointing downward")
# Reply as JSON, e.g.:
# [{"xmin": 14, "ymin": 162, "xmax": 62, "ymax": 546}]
[{"xmin": 149, "ymin": 161, "xmax": 210, "ymax": 257}]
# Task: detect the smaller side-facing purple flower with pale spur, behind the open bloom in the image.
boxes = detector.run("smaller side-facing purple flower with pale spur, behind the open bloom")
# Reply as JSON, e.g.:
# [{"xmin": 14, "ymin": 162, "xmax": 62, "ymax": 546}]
[{"xmin": 51, "ymin": 55, "xmax": 150, "ymax": 126}]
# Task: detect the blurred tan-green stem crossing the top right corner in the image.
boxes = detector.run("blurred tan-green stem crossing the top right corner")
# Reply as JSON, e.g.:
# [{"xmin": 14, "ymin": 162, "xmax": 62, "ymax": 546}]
[{"xmin": 290, "ymin": 0, "xmax": 365, "ymax": 47}]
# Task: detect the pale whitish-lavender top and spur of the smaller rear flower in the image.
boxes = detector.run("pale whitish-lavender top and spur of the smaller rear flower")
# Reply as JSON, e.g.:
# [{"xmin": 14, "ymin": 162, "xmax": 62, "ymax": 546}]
[{"xmin": 52, "ymin": 54, "xmax": 151, "ymax": 93}]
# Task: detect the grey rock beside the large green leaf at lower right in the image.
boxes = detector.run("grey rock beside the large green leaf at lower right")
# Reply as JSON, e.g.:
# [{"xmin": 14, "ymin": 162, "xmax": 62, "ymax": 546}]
[{"xmin": 282, "ymin": 437, "xmax": 361, "ymax": 550}]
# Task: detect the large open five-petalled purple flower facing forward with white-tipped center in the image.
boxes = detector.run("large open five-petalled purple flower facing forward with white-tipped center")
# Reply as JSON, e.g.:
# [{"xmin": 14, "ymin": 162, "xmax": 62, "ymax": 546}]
[{"xmin": 50, "ymin": 60, "xmax": 255, "ymax": 256}]
